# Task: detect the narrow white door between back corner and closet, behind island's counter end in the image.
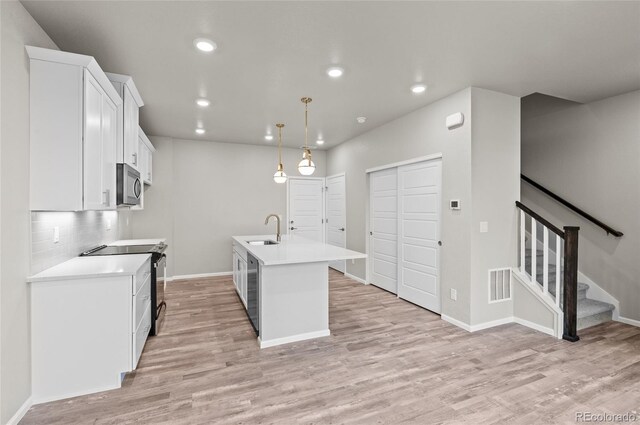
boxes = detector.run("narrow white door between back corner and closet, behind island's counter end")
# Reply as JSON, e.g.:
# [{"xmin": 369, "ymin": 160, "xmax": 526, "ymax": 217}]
[{"xmin": 325, "ymin": 174, "xmax": 347, "ymax": 273}]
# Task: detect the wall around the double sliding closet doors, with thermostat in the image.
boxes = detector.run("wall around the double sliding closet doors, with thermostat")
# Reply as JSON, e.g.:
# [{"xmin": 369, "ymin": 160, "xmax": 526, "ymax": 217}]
[{"xmin": 327, "ymin": 89, "xmax": 473, "ymax": 323}]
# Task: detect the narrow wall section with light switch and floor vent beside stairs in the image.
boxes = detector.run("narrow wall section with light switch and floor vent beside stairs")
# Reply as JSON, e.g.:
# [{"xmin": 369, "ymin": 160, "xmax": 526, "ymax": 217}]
[{"xmin": 471, "ymin": 88, "xmax": 520, "ymax": 325}]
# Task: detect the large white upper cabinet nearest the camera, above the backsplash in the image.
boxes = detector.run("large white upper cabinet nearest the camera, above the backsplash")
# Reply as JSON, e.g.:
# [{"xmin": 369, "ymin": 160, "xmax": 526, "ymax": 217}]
[{"xmin": 26, "ymin": 46, "xmax": 122, "ymax": 211}]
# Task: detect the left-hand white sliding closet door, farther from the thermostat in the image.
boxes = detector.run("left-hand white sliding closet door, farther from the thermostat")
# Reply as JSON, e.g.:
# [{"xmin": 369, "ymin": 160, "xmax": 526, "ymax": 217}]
[{"xmin": 369, "ymin": 168, "xmax": 398, "ymax": 294}]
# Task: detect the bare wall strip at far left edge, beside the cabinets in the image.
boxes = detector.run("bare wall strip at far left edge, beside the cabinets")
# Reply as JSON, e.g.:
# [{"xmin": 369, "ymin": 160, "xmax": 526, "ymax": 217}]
[{"xmin": 0, "ymin": 1, "xmax": 56, "ymax": 423}]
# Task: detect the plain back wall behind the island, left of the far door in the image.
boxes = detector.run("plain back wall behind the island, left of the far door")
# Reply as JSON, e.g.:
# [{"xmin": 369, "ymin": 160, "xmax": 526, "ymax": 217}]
[{"xmin": 131, "ymin": 137, "xmax": 326, "ymax": 276}]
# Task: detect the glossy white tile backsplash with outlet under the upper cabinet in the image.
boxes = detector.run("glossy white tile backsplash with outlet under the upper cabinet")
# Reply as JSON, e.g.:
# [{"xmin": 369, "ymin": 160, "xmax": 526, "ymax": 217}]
[{"xmin": 31, "ymin": 211, "xmax": 118, "ymax": 274}]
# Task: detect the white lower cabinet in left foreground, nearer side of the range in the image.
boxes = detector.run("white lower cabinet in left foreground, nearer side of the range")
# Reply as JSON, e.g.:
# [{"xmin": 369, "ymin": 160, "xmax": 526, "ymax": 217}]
[{"xmin": 31, "ymin": 260, "xmax": 151, "ymax": 403}]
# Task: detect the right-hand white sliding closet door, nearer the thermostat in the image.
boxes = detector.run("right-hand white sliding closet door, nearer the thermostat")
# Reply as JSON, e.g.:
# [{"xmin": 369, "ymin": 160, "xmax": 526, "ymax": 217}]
[{"xmin": 398, "ymin": 159, "xmax": 442, "ymax": 313}]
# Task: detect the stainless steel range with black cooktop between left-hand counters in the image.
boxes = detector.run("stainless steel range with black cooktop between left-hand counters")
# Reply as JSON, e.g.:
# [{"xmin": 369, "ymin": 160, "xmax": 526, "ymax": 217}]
[{"xmin": 80, "ymin": 242, "xmax": 168, "ymax": 336}]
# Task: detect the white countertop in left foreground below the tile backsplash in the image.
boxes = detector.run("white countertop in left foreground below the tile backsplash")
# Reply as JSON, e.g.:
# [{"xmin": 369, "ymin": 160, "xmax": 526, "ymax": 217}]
[{"xmin": 27, "ymin": 254, "xmax": 151, "ymax": 282}]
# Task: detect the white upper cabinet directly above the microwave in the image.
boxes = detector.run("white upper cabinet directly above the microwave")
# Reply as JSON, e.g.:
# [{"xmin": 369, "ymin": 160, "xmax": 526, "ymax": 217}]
[{"xmin": 106, "ymin": 72, "xmax": 144, "ymax": 171}]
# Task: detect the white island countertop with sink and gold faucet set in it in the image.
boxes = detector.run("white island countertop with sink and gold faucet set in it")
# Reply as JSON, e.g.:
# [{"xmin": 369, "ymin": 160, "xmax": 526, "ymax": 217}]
[{"xmin": 232, "ymin": 235, "xmax": 367, "ymax": 266}]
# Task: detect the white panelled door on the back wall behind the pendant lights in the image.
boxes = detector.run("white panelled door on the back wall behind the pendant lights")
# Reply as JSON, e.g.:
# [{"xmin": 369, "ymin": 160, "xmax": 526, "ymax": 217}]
[{"xmin": 287, "ymin": 178, "xmax": 324, "ymax": 242}]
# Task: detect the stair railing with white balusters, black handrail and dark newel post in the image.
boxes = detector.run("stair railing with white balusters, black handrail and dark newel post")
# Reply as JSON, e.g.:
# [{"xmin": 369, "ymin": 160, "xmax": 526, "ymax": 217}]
[{"xmin": 516, "ymin": 201, "xmax": 580, "ymax": 342}]
